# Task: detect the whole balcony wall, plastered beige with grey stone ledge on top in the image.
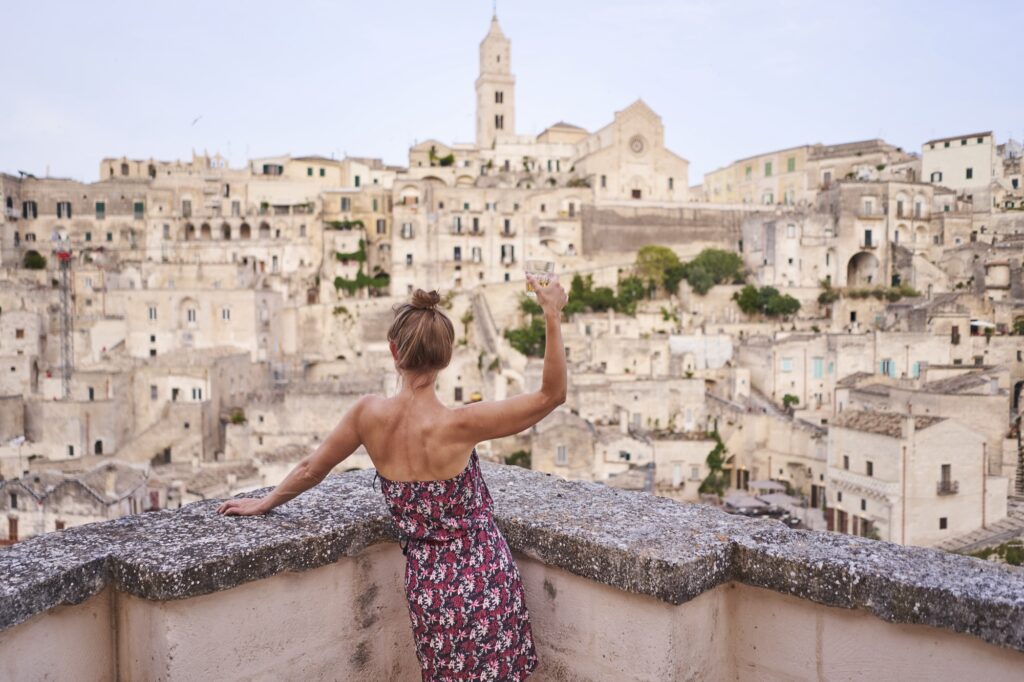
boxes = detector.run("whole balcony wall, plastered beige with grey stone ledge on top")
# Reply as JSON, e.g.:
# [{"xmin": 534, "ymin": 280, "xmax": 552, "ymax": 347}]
[{"xmin": 0, "ymin": 463, "xmax": 1024, "ymax": 681}]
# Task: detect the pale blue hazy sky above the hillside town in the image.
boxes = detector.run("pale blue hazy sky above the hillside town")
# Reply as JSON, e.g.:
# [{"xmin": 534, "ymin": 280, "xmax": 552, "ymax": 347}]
[{"xmin": 0, "ymin": 0, "xmax": 1024, "ymax": 184}]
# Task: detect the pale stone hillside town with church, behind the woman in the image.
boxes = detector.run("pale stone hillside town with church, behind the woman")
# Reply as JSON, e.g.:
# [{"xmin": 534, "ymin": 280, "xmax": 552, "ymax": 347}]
[{"xmin": 0, "ymin": 17, "xmax": 1024, "ymax": 563}]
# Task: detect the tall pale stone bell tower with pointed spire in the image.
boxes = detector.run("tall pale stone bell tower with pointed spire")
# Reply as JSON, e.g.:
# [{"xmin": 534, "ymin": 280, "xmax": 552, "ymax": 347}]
[{"xmin": 476, "ymin": 14, "xmax": 515, "ymax": 148}]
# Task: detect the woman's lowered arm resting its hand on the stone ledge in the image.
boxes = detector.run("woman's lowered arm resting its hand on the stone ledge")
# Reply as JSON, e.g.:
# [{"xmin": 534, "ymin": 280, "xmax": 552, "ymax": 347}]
[{"xmin": 217, "ymin": 395, "xmax": 374, "ymax": 516}]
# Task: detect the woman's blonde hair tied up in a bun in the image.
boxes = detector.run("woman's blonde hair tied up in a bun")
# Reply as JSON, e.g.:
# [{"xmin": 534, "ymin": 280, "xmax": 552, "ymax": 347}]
[{"xmin": 387, "ymin": 289, "xmax": 455, "ymax": 372}]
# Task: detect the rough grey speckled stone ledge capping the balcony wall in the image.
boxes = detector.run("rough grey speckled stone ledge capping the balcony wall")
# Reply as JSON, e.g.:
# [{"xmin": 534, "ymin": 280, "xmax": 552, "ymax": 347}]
[{"xmin": 0, "ymin": 463, "xmax": 1024, "ymax": 651}]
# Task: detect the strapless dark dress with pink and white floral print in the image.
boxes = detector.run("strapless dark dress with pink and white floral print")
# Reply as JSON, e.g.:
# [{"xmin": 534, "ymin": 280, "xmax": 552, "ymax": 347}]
[{"xmin": 374, "ymin": 449, "xmax": 538, "ymax": 680}]
